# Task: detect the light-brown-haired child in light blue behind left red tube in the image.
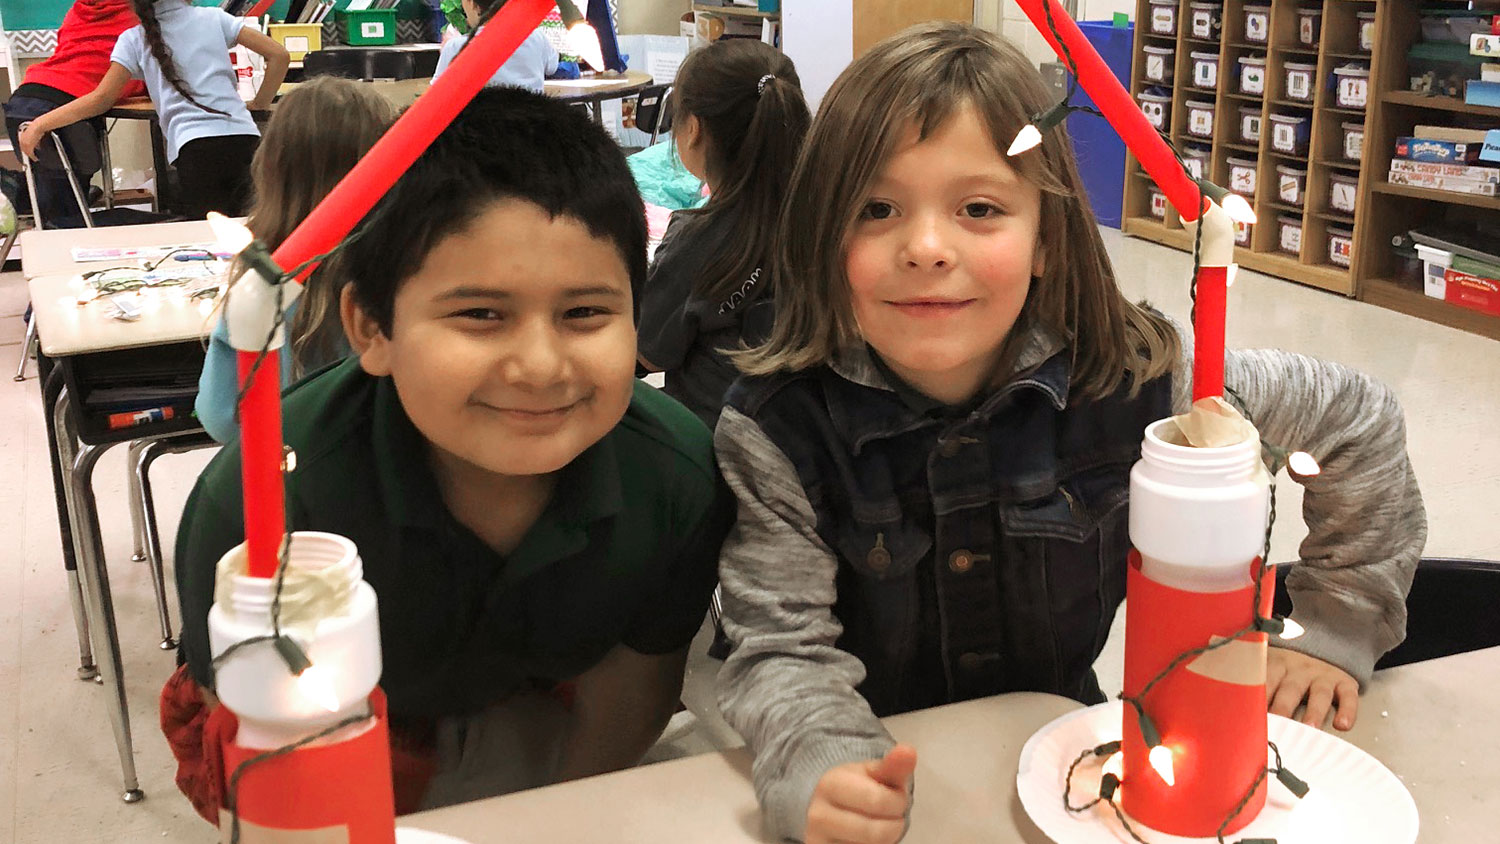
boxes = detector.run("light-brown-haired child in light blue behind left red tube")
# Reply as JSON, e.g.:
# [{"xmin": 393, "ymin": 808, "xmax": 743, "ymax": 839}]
[{"xmin": 195, "ymin": 76, "xmax": 395, "ymax": 442}]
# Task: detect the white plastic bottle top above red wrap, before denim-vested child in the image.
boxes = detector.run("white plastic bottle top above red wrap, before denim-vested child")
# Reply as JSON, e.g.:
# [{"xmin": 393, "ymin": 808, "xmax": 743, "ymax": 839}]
[{"xmin": 1130, "ymin": 418, "xmax": 1271, "ymax": 592}]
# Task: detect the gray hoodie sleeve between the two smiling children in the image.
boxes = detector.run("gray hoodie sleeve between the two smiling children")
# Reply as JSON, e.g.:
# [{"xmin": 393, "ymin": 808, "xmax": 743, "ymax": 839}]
[{"xmin": 714, "ymin": 408, "xmax": 894, "ymax": 841}]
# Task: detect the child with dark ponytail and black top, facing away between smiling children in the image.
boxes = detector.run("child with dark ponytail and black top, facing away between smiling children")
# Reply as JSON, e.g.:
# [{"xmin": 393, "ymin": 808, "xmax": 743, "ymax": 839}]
[{"xmin": 638, "ymin": 39, "xmax": 812, "ymax": 427}]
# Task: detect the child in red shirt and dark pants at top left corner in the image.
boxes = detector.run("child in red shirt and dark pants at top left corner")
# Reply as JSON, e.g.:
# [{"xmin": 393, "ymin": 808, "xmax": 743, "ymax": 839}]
[{"xmin": 5, "ymin": 0, "xmax": 146, "ymax": 228}]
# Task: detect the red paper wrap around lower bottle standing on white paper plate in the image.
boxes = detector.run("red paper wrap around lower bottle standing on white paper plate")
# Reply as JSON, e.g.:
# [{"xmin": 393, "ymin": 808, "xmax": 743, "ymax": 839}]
[{"xmin": 1119, "ymin": 550, "xmax": 1275, "ymax": 838}]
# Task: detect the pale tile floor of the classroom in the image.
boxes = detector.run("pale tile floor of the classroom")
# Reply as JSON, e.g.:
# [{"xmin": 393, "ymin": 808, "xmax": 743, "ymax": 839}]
[{"xmin": 0, "ymin": 229, "xmax": 1500, "ymax": 844}]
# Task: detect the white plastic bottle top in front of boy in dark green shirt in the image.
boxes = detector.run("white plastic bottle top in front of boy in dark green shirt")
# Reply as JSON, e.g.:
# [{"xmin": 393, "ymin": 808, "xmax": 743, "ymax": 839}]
[{"xmin": 209, "ymin": 531, "xmax": 381, "ymax": 748}]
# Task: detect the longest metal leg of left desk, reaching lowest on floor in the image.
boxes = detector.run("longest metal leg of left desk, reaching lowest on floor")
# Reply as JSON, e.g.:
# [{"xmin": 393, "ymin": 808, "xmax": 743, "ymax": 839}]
[{"xmin": 56, "ymin": 390, "xmax": 146, "ymax": 804}]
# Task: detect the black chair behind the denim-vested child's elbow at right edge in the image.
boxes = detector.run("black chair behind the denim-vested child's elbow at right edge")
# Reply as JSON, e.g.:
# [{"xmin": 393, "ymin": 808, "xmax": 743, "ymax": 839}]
[{"xmin": 1275, "ymin": 558, "xmax": 1500, "ymax": 670}]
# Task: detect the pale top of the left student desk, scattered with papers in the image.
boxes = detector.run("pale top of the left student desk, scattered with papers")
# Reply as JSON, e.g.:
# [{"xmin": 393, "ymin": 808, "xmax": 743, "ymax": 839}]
[{"xmin": 21, "ymin": 220, "xmax": 225, "ymax": 357}]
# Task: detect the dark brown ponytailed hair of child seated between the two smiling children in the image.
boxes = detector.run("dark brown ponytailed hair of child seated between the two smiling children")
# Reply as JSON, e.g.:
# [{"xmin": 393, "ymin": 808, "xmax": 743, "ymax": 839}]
[{"xmin": 672, "ymin": 39, "xmax": 812, "ymax": 300}]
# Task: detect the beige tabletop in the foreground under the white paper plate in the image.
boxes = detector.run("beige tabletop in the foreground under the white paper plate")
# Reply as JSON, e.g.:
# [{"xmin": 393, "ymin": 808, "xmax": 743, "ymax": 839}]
[{"xmin": 401, "ymin": 648, "xmax": 1500, "ymax": 844}]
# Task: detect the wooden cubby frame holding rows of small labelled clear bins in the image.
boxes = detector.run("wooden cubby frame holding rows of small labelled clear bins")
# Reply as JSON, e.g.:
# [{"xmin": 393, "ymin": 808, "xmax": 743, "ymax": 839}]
[{"xmin": 1121, "ymin": 0, "xmax": 1368, "ymax": 295}]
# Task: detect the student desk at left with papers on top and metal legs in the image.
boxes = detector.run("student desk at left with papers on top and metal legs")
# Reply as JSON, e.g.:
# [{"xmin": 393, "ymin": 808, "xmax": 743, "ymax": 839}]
[{"xmin": 21, "ymin": 220, "xmax": 225, "ymax": 802}]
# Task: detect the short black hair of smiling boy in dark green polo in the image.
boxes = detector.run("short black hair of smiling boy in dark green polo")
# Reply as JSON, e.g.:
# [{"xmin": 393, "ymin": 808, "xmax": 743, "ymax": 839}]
[{"xmin": 341, "ymin": 87, "xmax": 647, "ymax": 336}]
